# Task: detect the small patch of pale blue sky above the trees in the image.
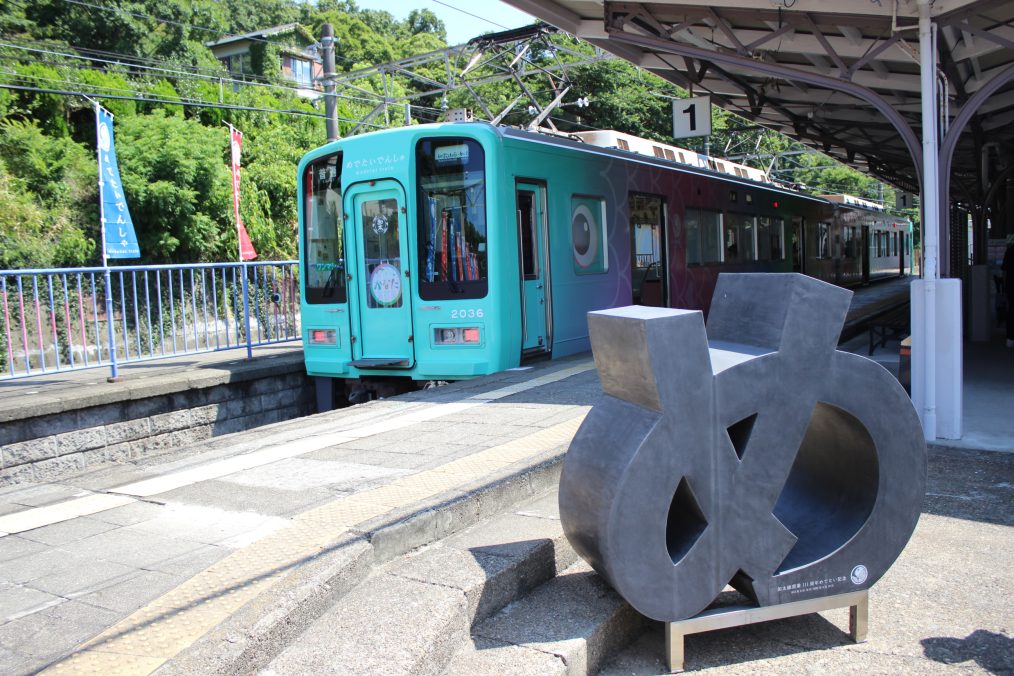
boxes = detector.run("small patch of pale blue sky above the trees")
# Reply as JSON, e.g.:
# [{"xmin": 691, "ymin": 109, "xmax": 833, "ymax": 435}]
[{"xmin": 356, "ymin": 0, "xmax": 535, "ymax": 45}]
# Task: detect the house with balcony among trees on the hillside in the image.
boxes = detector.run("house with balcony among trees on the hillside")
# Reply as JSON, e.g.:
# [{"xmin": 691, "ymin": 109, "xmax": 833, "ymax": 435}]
[{"xmin": 205, "ymin": 23, "xmax": 323, "ymax": 98}]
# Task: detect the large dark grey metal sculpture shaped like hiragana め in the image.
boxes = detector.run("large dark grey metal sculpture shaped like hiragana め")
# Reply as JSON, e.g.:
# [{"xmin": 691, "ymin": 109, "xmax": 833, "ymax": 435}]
[{"xmin": 560, "ymin": 274, "xmax": 926, "ymax": 621}]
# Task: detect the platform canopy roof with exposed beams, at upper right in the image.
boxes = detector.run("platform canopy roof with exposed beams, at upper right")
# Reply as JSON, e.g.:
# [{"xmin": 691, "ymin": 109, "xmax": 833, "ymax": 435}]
[{"xmin": 505, "ymin": 0, "xmax": 1014, "ymax": 199}]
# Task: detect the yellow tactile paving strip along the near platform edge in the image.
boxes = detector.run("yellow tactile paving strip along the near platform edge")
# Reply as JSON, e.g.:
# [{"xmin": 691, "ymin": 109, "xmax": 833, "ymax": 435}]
[{"xmin": 44, "ymin": 365, "xmax": 592, "ymax": 674}]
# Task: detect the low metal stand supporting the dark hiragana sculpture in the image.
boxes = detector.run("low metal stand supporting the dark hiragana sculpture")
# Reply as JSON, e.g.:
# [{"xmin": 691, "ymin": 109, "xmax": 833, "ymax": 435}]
[{"xmin": 665, "ymin": 590, "xmax": 870, "ymax": 672}]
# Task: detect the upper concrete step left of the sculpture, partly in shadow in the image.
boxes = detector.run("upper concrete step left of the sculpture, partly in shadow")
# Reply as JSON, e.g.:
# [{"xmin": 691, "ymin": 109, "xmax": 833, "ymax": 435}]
[{"xmin": 265, "ymin": 489, "xmax": 576, "ymax": 674}]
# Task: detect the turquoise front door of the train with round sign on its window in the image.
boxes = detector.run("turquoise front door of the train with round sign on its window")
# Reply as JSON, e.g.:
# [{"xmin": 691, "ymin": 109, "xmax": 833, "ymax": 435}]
[{"xmin": 345, "ymin": 180, "xmax": 415, "ymax": 369}]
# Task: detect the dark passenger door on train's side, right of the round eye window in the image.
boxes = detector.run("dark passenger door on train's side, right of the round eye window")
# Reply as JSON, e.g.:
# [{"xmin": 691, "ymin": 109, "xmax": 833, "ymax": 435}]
[{"xmin": 629, "ymin": 194, "xmax": 669, "ymax": 307}]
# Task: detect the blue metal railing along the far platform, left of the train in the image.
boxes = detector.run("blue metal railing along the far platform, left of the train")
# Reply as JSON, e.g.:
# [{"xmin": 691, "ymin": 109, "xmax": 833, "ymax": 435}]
[{"xmin": 0, "ymin": 260, "xmax": 300, "ymax": 379}]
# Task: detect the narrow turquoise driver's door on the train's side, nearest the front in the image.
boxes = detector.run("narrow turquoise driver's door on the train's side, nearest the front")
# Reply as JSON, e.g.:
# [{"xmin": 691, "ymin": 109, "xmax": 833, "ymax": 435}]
[{"xmin": 516, "ymin": 181, "xmax": 550, "ymax": 352}]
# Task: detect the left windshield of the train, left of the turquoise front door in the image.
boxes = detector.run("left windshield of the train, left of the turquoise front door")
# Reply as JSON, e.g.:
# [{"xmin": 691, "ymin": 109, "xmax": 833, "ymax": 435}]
[{"xmin": 303, "ymin": 153, "xmax": 347, "ymax": 303}]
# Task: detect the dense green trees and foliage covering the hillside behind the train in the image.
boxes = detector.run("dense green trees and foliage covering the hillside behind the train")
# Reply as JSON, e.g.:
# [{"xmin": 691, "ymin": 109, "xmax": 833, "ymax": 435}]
[{"xmin": 0, "ymin": 0, "xmax": 904, "ymax": 269}]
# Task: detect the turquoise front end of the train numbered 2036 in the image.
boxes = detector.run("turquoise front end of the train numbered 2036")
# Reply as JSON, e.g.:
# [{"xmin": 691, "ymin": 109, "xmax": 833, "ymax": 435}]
[{"xmin": 299, "ymin": 125, "xmax": 511, "ymax": 408}]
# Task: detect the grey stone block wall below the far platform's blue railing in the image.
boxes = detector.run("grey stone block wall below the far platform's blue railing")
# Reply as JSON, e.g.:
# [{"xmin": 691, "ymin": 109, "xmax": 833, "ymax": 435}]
[{"xmin": 0, "ymin": 355, "xmax": 314, "ymax": 487}]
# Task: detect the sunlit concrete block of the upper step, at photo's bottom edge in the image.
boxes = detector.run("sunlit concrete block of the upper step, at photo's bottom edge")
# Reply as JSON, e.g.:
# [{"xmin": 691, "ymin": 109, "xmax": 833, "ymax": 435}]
[{"xmin": 268, "ymin": 576, "xmax": 467, "ymax": 674}]
